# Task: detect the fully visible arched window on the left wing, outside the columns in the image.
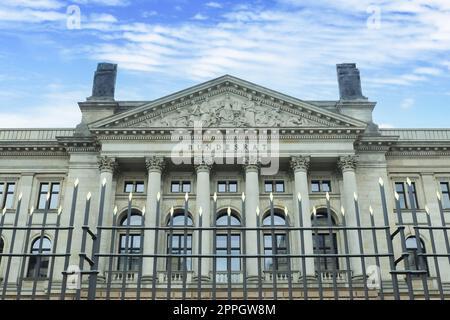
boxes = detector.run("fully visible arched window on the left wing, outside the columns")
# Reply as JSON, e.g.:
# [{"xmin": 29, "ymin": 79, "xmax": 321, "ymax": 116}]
[{"xmin": 27, "ymin": 237, "xmax": 52, "ymax": 278}]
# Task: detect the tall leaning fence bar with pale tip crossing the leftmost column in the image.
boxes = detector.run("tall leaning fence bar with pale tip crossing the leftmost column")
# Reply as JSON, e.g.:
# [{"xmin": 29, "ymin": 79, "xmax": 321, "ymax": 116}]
[{"xmin": 88, "ymin": 179, "xmax": 106, "ymax": 300}]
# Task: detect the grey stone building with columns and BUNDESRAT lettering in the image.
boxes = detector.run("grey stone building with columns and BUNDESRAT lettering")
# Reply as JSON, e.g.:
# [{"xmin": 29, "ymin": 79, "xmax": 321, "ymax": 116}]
[{"xmin": 0, "ymin": 64, "xmax": 450, "ymax": 299}]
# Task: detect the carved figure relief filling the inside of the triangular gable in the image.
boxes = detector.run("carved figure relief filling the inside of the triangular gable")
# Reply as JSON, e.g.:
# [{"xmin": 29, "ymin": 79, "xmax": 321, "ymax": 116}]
[{"xmin": 134, "ymin": 93, "xmax": 320, "ymax": 128}]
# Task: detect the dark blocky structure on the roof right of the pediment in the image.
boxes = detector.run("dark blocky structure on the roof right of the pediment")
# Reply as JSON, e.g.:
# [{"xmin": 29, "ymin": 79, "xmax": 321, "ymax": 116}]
[{"xmin": 336, "ymin": 63, "xmax": 367, "ymax": 100}]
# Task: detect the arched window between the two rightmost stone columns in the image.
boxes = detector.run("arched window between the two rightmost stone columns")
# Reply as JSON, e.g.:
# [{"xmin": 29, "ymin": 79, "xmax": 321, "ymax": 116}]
[{"xmin": 311, "ymin": 209, "xmax": 339, "ymax": 271}]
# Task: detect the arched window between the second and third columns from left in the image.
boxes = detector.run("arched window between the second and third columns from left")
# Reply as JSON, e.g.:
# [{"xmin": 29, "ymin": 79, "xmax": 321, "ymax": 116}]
[{"xmin": 167, "ymin": 209, "xmax": 194, "ymax": 271}]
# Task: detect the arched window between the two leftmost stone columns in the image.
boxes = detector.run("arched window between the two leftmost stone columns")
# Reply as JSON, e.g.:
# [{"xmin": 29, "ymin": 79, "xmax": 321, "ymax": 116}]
[{"xmin": 117, "ymin": 210, "xmax": 142, "ymax": 271}]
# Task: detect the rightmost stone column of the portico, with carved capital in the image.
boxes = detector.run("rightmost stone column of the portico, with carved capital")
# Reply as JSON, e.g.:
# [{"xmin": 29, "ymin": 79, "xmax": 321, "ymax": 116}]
[{"xmin": 338, "ymin": 155, "xmax": 363, "ymax": 277}]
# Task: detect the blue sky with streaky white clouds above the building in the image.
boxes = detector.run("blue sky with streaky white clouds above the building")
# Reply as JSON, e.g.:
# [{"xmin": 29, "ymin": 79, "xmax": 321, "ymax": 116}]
[{"xmin": 0, "ymin": 0, "xmax": 450, "ymax": 127}]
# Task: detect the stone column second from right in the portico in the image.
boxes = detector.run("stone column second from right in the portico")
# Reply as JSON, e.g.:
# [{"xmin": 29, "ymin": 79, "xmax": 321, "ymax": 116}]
[{"xmin": 290, "ymin": 156, "xmax": 315, "ymax": 277}]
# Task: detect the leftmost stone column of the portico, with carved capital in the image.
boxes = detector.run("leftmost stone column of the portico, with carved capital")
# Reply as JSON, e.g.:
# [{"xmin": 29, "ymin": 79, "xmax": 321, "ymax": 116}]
[{"xmin": 97, "ymin": 157, "xmax": 117, "ymax": 279}]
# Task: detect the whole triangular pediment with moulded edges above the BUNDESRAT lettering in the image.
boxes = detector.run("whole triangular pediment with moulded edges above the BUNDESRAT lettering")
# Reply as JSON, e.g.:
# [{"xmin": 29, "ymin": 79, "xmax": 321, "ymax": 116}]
[{"xmin": 90, "ymin": 75, "xmax": 366, "ymax": 129}]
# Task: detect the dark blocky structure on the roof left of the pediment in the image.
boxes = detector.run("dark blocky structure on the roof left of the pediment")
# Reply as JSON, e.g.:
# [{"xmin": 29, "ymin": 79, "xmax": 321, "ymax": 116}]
[{"xmin": 88, "ymin": 63, "xmax": 117, "ymax": 101}]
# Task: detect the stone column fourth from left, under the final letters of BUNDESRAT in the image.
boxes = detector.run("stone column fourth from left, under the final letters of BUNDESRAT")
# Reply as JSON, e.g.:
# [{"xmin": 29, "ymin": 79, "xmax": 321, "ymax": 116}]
[{"xmin": 244, "ymin": 164, "xmax": 263, "ymax": 281}]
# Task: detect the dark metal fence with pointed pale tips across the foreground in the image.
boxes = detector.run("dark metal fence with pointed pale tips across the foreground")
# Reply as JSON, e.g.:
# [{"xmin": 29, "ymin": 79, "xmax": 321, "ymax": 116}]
[{"xmin": 0, "ymin": 179, "xmax": 450, "ymax": 300}]
